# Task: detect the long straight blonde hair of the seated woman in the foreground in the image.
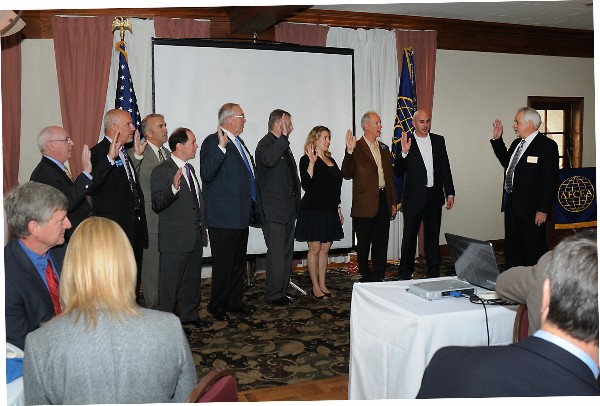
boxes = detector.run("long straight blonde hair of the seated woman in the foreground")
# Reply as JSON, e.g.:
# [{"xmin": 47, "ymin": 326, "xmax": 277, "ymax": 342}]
[{"xmin": 60, "ymin": 217, "xmax": 139, "ymax": 327}]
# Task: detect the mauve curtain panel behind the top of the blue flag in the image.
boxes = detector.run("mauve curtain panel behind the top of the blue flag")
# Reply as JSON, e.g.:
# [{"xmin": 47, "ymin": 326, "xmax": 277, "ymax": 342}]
[{"xmin": 396, "ymin": 30, "xmax": 437, "ymax": 114}]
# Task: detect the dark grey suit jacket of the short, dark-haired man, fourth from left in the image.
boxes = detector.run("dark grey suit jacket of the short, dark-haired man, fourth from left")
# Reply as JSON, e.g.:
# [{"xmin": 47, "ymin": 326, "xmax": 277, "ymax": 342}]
[{"xmin": 151, "ymin": 157, "xmax": 208, "ymax": 252}]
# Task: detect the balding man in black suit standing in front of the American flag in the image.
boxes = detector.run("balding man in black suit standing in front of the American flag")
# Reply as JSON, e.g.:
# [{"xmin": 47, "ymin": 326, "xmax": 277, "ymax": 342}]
[{"xmin": 90, "ymin": 109, "xmax": 148, "ymax": 300}]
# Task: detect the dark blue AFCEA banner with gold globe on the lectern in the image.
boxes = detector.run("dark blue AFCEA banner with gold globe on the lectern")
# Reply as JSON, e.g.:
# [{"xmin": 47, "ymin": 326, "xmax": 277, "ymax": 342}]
[{"xmin": 554, "ymin": 168, "xmax": 597, "ymax": 229}]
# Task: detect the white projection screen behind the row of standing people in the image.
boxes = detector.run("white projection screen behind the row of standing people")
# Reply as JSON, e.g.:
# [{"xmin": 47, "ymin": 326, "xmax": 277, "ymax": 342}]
[{"xmin": 153, "ymin": 39, "xmax": 354, "ymax": 256}]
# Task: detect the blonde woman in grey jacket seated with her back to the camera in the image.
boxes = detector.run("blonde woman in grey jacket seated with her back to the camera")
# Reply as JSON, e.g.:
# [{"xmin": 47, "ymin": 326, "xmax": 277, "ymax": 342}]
[{"xmin": 23, "ymin": 217, "xmax": 197, "ymax": 405}]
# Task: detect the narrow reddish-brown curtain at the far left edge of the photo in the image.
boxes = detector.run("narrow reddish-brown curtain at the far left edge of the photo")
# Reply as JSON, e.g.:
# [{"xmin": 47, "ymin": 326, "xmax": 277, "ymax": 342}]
[{"xmin": 0, "ymin": 32, "xmax": 22, "ymax": 193}]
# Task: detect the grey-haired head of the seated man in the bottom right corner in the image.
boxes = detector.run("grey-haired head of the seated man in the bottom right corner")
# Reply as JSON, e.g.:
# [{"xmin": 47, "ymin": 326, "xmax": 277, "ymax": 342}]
[{"xmin": 546, "ymin": 231, "xmax": 598, "ymax": 346}]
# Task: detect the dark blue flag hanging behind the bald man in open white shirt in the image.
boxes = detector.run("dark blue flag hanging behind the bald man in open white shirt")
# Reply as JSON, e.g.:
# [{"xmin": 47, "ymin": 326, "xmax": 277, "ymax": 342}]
[{"xmin": 392, "ymin": 48, "xmax": 417, "ymax": 204}]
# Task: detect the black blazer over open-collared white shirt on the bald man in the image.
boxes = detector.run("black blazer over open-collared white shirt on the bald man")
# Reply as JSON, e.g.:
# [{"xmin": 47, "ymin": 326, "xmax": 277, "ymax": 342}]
[{"xmin": 394, "ymin": 133, "xmax": 455, "ymax": 211}]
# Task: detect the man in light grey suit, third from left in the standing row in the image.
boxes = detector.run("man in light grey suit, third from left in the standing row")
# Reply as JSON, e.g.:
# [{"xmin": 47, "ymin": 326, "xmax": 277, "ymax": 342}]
[{"xmin": 128, "ymin": 114, "xmax": 171, "ymax": 309}]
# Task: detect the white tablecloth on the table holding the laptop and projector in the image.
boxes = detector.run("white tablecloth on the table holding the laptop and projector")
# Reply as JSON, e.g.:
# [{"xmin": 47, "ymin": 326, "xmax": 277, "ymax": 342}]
[{"xmin": 348, "ymin": 278, "xmax": 516, "ymax": 400}]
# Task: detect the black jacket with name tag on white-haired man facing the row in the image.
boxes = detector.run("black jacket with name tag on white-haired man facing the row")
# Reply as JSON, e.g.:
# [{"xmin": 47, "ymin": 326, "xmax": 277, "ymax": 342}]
[{"xmin": 490, "ymin": 133, "xmax": 558, "ymax": 219}]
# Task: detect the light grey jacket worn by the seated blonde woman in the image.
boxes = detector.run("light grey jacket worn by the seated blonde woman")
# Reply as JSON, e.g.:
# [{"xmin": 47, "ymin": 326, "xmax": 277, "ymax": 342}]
[{"xmin": 23, "ymin": 308, "xmax": 197, "ymax": 405}]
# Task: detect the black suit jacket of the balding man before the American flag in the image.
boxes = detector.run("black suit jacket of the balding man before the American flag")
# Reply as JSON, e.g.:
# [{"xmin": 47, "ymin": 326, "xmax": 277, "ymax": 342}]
[{"xmin": 90, "ymin": 137, "xmax": 148, "ymax": 248}]
